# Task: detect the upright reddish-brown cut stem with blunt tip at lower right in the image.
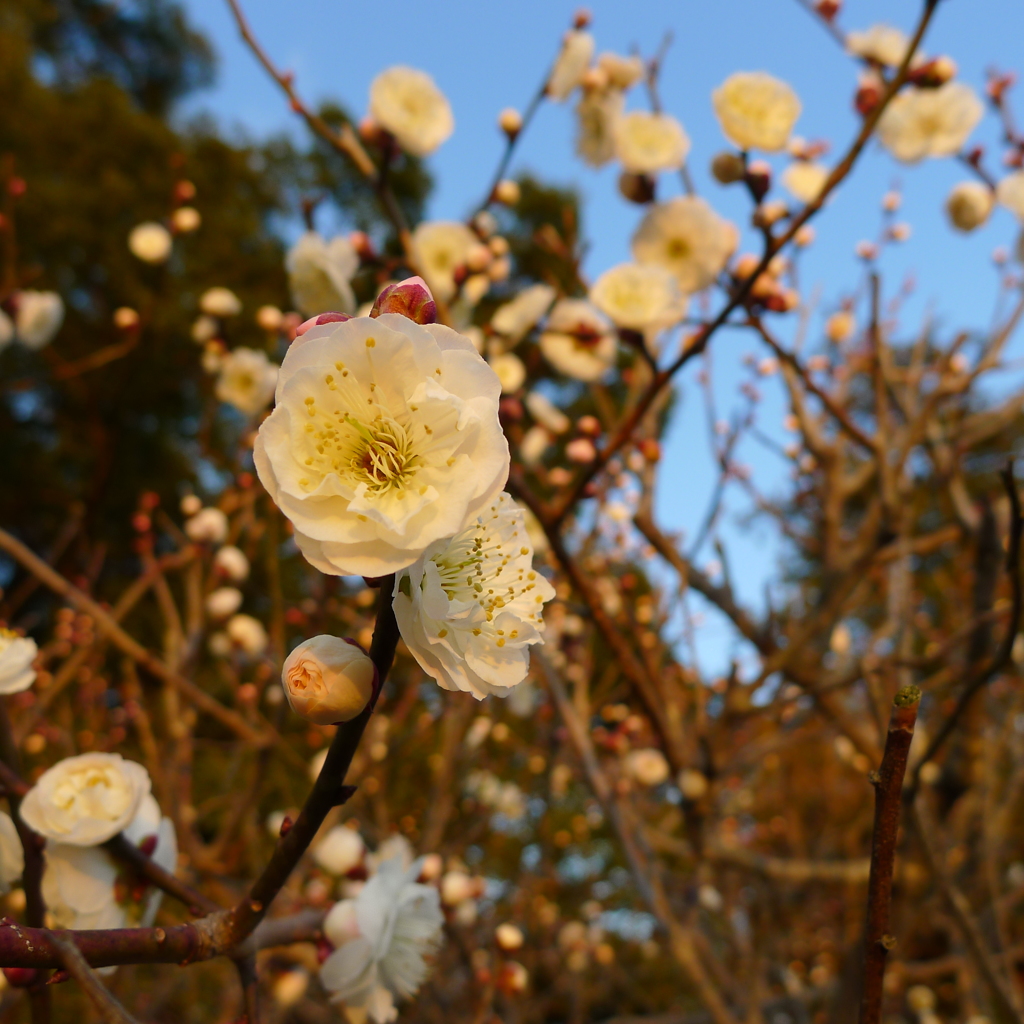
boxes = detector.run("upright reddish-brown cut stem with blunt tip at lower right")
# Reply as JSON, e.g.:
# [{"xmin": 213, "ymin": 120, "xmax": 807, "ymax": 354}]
[{"xmin": 860, "ymin": 686, "xmax": 921, "ymax": 1024}]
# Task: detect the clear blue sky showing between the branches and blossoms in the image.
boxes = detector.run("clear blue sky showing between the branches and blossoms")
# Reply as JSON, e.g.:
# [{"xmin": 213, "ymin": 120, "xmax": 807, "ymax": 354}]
[{"xmin": 184, "ymin": 0, "xmax": 1024, "ymax": 656}]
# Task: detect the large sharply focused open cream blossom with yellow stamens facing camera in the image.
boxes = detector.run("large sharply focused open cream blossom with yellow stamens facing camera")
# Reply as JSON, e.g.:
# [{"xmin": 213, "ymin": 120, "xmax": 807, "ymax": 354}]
[{"xmin": 254, "ymin": 313, "xmax": 509, "ymax": 577}]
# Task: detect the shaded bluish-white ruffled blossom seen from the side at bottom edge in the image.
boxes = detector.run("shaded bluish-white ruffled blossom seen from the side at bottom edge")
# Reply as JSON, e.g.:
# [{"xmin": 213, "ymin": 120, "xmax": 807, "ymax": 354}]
[{"xmin": 321, "ymin": 857, "xmax": 444, "ymax": 1024}]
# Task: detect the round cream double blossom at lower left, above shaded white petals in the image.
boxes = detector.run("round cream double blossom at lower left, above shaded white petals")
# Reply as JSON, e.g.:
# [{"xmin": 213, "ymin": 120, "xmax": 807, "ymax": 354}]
[{"xmin": 22, "ymin": 754, "xmax": 151, "ymax": 846}]
